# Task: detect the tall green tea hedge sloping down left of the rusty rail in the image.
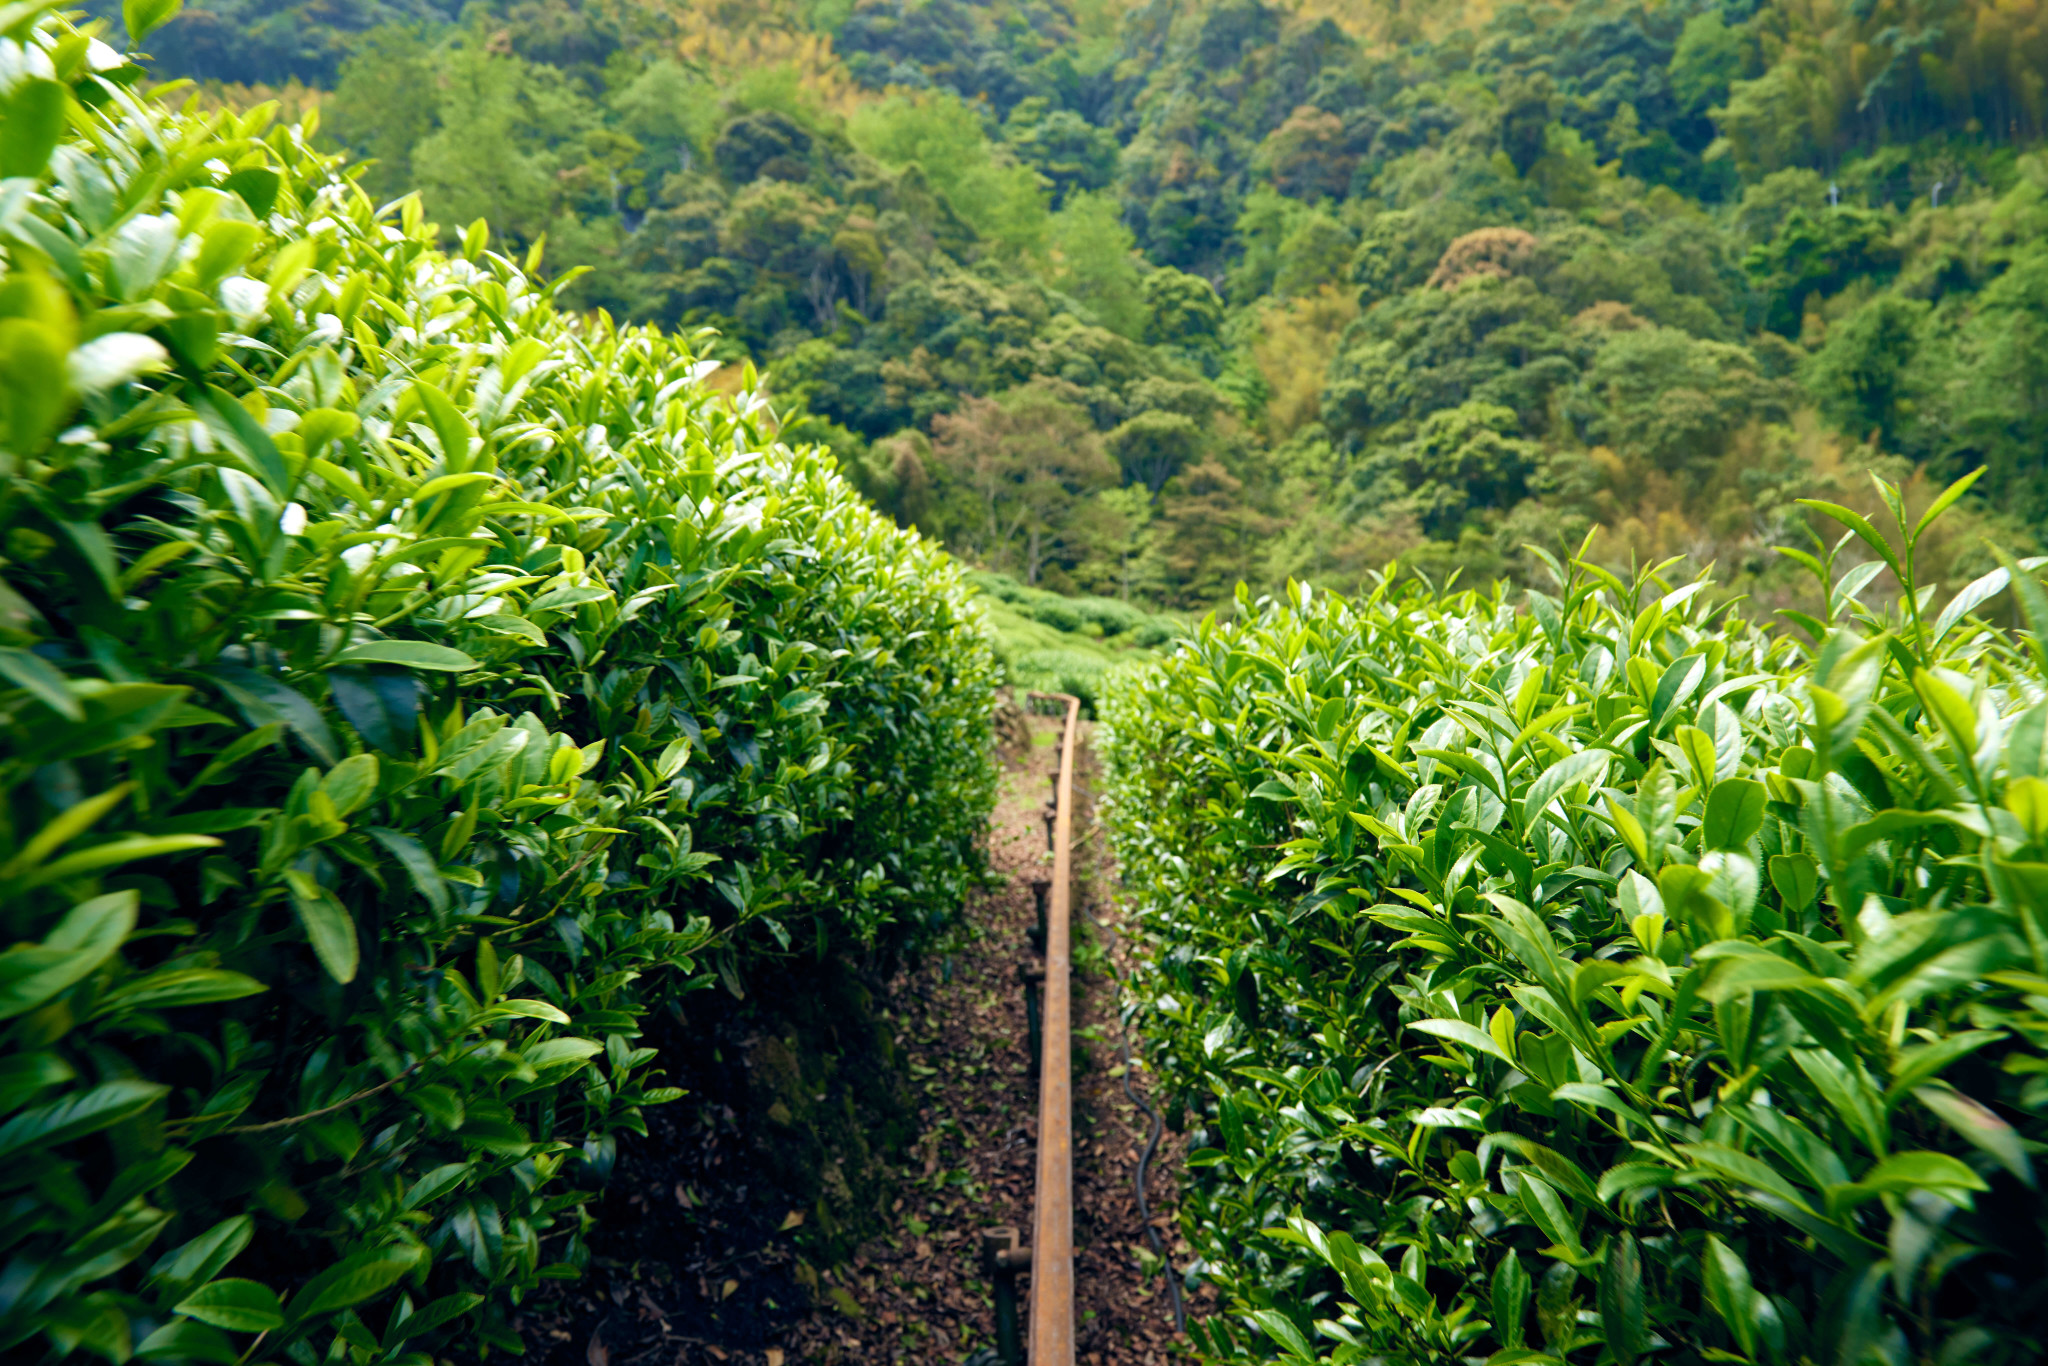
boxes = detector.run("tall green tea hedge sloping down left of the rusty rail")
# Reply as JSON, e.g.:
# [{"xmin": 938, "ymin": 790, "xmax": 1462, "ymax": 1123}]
[{"xmin": 0, "ymin": 0, "xmax": 995, "ymax": 1366}]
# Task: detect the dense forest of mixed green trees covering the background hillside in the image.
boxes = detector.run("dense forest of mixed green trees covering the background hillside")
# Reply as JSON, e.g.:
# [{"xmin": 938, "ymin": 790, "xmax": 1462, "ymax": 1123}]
[{"xmin": 119, "ymin": 0, "xmax": 2048, "ymax": 608}]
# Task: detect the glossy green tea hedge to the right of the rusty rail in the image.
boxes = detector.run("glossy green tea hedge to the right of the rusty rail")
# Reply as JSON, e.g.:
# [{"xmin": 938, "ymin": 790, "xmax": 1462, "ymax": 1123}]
[{"xmin": 1102, "ymin": 497, "xmax": 2048, "ymax": 1366}]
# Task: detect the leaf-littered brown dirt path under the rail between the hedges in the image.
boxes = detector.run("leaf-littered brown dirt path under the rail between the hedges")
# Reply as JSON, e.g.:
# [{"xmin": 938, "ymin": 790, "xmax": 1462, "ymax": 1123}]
[{"xmin": 520, "ymin": 717, "xmax": 1186, "ymax": 1366}]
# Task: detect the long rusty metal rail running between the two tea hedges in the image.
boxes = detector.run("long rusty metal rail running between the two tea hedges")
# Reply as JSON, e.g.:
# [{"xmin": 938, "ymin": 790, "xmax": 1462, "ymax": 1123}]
[{"xmin": 1030, "ymin": 692, "xmax": 1081, "ymax": 1366}]
